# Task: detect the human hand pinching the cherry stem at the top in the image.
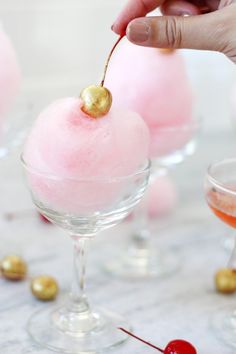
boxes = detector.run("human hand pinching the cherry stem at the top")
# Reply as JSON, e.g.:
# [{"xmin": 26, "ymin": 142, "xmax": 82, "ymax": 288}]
[{"xmin": 113, "ymin": 0, "xmax": 236, "ymax": 63}]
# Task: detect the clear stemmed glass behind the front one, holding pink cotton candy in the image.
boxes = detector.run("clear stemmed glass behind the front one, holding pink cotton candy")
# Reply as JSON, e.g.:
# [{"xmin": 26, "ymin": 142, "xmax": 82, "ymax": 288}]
[{"xmin": 105, "ymin": 119, "xmax": 199, "ymax": 279}]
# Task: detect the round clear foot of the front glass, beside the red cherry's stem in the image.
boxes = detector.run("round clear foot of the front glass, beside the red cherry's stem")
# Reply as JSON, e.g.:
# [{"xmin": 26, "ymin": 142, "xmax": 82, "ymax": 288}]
[{"xmin": 27, "ymin": 307, "xmax": 130, "ymax": 354}]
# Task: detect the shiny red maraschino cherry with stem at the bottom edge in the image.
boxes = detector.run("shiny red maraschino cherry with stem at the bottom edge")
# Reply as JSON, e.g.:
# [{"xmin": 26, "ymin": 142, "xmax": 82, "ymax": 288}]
[{"xmin": 119, "ymin": 327, "xmax": 197, "ymax": 354}]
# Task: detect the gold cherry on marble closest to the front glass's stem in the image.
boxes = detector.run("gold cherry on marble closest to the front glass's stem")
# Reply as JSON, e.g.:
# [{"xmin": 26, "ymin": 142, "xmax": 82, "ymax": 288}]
[{"xmin": 31, "ymin": 275, "xmax": 59, "ymax": 301}]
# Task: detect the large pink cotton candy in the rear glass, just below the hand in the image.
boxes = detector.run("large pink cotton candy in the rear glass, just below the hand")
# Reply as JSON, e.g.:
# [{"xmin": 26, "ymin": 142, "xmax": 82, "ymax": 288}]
[{"xmin": 105, "ymin": 38, "xmax": 193, "ymax": 157}]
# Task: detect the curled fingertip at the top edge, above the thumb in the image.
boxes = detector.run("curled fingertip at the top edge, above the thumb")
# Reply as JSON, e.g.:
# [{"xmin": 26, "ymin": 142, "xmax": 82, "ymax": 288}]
[{"xmin": 161, "ymin": 0, "xmax": 202, "ymax": 16}]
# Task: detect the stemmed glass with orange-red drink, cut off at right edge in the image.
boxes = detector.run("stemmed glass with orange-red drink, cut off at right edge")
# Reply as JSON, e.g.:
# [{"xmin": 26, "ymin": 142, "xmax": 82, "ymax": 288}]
[{"xmin": 204, "ymin": 158, "xmax": 236, "ymax": 347}]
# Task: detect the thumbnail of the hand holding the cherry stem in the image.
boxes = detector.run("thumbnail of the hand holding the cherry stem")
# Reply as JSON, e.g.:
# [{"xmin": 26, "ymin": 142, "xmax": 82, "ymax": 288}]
[{"xmin": 127, "ymin": 20, "xmax": 150, "ymax": 43}]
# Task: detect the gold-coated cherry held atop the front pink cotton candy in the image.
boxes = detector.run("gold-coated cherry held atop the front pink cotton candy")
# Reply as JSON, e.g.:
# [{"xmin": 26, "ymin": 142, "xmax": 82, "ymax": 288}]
[{"xmin": 80, "ymin": 85, "xmax": 112, "ymax": 118}]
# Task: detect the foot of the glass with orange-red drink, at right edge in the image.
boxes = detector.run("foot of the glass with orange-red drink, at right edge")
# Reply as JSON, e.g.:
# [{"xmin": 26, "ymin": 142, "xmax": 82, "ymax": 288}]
[{"xmin": 212, "ymin": 305, "xmax": 236, "ymax": 348}]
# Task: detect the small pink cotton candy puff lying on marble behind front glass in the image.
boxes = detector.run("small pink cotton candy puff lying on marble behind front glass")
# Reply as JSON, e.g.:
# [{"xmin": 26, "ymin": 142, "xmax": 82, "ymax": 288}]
[{"xmin": 147, "ymin": 175, "xmax": 177, "ymax": 218}]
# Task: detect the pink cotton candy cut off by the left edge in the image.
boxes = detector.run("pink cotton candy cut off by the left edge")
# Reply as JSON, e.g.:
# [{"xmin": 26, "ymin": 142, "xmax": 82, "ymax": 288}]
[{"xmin": 0, "ymin": 28, "xmax": 21, "ymax": 118}]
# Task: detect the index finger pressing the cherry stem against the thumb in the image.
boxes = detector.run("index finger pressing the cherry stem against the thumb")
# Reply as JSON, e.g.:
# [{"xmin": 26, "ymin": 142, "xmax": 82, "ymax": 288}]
[{"xmin": 112, "ymin": 0, "xmax": 164, "ymax": 35}]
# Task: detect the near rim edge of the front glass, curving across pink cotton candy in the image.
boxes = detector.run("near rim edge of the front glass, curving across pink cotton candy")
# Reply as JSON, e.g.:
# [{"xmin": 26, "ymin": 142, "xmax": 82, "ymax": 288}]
[{"xmin": 20, "ymin": 153, "xmax": 151, "ymax": 183}]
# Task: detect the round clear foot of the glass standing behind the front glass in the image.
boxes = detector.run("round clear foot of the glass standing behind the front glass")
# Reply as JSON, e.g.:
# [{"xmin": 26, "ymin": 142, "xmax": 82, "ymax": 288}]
[{"xmin": 105, "ymin": 246, "xmax": 179, "ymax": 279}]
